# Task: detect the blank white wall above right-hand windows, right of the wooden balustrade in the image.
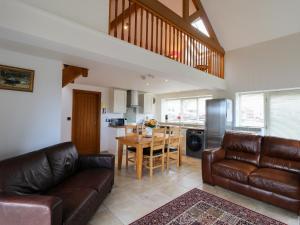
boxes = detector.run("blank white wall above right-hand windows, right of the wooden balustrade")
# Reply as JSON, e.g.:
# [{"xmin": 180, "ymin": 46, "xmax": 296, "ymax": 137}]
[{"xmin": 225, "ymin": 33, "xmax": 300, "ymax": 97}]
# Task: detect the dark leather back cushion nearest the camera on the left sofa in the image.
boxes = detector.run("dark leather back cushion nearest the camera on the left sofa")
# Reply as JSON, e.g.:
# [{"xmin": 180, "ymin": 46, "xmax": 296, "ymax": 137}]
[{"xmin": 0, "ymin": 151, "xmax": 54, "ymax": 195}]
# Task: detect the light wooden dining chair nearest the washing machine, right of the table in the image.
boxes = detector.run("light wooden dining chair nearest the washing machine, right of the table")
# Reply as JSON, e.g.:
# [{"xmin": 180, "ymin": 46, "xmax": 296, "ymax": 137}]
[{"xmin": 165, "ymin": 127, "xmax": 181, "ymax": 169}]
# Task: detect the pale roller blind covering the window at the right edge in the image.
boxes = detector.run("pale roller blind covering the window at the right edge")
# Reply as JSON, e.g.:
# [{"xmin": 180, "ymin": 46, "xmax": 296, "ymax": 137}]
[{"xmin": 268, "ymin": 90, "xmax": 300, "ymax": 139}]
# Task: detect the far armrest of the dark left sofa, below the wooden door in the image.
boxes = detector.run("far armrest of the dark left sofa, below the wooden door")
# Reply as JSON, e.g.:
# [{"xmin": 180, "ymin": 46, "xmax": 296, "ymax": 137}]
[{"xmin": 79, "ymin": 154, "xmax": 115, "ymax": 170}]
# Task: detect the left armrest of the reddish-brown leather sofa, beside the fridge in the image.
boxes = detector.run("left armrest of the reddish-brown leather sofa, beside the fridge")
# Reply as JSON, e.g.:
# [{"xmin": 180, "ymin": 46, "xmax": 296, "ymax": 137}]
[{"xmin": 202, "ymin": 148, "xmax": 225, "ymax": 185}]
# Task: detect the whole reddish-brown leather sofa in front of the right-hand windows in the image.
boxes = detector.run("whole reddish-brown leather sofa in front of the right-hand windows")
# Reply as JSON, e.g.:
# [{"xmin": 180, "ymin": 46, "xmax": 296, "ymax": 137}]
[{"xmin": 202, "ymin": 133, "xmax": 300, "ymax": 214}]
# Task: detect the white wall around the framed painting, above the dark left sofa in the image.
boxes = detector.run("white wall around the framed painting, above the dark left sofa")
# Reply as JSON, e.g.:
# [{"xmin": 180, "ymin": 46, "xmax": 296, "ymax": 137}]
[{"xmin": 0, "ymin": 49, "xmax": 62, "ymax": 159}]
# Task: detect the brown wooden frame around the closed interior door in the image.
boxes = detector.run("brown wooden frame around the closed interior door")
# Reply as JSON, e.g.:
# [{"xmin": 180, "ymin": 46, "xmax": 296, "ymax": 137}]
[{"xmin": 71, "ymin": 89, "xmax": 101, "ymax": 154}]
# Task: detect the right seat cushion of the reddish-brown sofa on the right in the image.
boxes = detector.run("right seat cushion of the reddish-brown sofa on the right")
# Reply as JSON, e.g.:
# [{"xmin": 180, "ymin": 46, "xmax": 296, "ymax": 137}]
[{"xmin": 249, "ymin": 168, "xmax": 300, "ymax": 200}]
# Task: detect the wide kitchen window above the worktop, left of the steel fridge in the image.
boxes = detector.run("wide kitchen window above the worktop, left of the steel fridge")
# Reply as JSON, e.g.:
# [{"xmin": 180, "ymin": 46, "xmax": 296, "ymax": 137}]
[{"xmin": 161, "ymin": 97, "xmax": 211, "ymax": 124}]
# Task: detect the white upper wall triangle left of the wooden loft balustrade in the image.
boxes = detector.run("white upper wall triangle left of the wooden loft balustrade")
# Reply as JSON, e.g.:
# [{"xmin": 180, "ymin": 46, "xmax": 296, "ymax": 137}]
[{"xmin": 19, "ymin": 0, "xmax": 109, "ymax": 33}]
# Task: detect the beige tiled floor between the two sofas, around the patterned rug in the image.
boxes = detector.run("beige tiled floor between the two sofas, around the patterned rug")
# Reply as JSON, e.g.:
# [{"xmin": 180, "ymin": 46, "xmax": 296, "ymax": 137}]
[{"xmin": 88, "ymin": 158, "xmax": 298, "ymax": 225}]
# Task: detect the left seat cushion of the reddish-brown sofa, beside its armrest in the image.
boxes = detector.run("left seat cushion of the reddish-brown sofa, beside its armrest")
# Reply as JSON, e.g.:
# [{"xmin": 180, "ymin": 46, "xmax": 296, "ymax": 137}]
[{"xmin": 212, "ymin": 160, "xmax": 257, "ymax": 184}]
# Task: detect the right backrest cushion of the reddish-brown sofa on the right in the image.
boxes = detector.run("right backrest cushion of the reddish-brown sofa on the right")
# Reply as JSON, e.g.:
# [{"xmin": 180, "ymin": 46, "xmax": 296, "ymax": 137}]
[{"xmin": 260, "ymin": 137, "xmax": 300, "ymax": 175}]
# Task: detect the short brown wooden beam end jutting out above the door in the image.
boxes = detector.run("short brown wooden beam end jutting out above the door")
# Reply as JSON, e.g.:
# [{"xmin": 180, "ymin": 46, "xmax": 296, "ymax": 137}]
[{"xmin": 62, "ymin": 65, "xmax": 88, "ymax": 87}]
